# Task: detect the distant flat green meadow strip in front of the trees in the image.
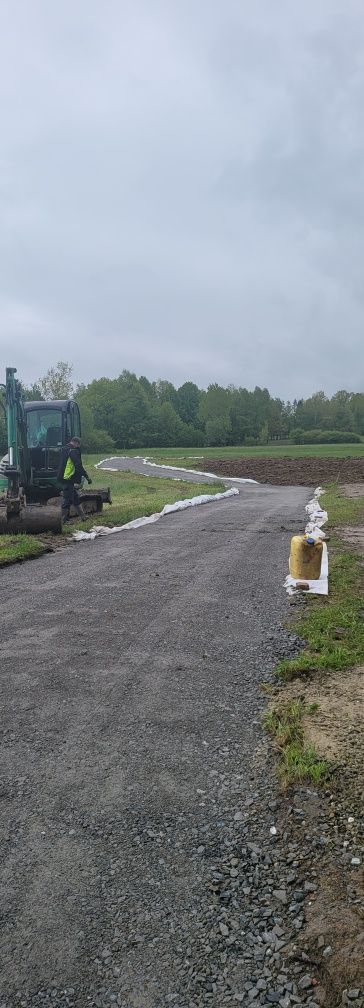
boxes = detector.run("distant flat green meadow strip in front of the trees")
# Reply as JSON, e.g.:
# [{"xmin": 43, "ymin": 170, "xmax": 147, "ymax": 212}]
[{"xmin": 110, "ymin": 442, "xmax": 364, "ymax": 468}]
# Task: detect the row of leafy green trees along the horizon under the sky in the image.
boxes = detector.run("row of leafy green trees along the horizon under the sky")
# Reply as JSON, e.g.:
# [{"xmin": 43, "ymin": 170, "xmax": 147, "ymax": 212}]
[{"xmin": 0, "ymin": 361, "xmax": 364, "ymax": 452}]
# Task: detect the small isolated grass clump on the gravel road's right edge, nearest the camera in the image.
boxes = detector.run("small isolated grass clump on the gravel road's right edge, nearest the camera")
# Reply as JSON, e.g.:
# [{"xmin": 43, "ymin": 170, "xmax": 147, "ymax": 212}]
[{"xmin": 264, "ymin": 700, "xmax": 330, "ymax": 786}]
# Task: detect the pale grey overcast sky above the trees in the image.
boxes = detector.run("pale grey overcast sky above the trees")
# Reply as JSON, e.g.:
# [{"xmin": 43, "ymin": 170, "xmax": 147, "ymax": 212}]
[{"xmin": 0, "ymin": 0, "xmax": 364, "ymax": 399}]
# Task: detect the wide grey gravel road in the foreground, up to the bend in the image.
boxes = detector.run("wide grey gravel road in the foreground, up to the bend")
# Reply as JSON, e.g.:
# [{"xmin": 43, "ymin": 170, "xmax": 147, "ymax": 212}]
[{"xmin": 0, "ymin": 485, "xmax": 326, "ymax": 1008}]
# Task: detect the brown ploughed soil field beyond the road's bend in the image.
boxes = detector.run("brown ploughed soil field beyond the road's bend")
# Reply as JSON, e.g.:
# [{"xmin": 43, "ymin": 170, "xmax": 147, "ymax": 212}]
[{"xmin": 199, "ymin": 456, "xmax": 364, "ymax": 487}]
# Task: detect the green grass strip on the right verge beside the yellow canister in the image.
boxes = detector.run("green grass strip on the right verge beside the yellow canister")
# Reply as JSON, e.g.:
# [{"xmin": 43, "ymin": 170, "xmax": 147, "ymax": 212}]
[{"xmin": 276, "ymin": 486, "xmax": 364, "ymax": 680}]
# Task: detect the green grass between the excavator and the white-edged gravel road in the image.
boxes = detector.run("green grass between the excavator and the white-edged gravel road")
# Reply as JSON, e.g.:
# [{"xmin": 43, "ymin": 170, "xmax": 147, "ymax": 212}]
[{"xmin": 70, "ymin": 455, "xmax": 226, "ymax": 534}]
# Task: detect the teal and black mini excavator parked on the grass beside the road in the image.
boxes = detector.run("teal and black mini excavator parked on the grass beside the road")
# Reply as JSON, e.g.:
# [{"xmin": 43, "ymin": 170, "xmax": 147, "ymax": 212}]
[{"xmin": 0, "ymin": 368, "xmax": 111, "ymax": 534}]
